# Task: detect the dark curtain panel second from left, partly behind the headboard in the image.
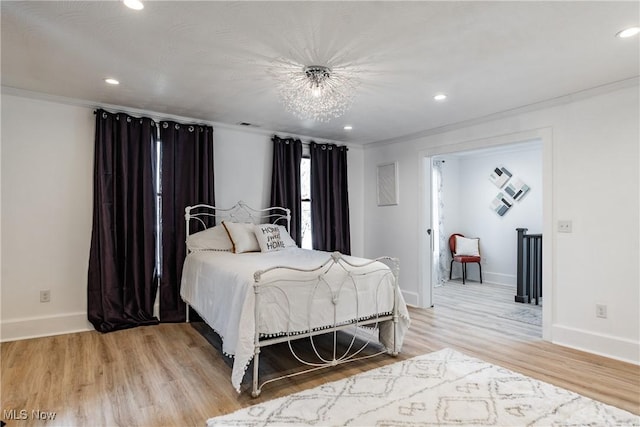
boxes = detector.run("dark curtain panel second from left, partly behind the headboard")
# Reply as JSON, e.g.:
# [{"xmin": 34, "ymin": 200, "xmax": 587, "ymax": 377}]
[{"xmin": 160, "ymin": 121, "xmax": 215, "ymax": 322}]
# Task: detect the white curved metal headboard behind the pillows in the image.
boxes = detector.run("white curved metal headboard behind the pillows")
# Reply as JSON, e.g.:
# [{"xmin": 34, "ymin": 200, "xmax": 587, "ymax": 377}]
[{"xmin": 184, "ymin": 200, "xmax": 291, "ymax": 236}]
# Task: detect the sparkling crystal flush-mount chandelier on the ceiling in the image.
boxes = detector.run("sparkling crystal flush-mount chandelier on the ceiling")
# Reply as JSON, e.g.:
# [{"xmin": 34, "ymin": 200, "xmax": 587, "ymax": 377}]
[{"xmin": 272, "ymin": 60, "xmax": 358, "ymax": 122}]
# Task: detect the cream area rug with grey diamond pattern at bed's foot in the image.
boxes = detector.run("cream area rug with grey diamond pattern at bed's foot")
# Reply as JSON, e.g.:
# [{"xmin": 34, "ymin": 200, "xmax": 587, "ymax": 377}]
[{"xmin": 207, "ymin": 349, "xmax": 640, "ymax": 427}]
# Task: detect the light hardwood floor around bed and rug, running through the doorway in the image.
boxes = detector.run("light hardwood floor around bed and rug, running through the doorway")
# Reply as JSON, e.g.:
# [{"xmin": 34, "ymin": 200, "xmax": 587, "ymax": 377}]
[{"xmin": 0, "ymin": 282, "xmax": 640, "ymax": 426}]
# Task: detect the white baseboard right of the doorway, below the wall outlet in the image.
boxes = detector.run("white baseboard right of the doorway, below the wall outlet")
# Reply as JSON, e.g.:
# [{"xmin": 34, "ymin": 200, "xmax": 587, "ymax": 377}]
[{"xmin": 551, "ymin": 325, "xmax": 640, "ymax": 365}]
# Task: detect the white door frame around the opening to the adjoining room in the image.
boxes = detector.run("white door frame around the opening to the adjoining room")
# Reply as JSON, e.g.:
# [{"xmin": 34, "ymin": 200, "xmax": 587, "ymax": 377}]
[{"xmin": 418, "ymin": 127, "xmax": 556, "ymax": 341}]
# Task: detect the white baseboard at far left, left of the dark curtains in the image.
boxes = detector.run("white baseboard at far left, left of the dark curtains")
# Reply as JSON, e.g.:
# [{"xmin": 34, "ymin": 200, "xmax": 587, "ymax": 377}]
[{"xmin": 0, "ymin": 312, "xmax": 94, "ymax": 342}]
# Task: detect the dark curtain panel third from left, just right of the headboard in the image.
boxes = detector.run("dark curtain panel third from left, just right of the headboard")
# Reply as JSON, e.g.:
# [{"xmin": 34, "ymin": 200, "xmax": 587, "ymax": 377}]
[{"xmin": 270, "ymin": 135, "xmax": 302, "ymax": 246}]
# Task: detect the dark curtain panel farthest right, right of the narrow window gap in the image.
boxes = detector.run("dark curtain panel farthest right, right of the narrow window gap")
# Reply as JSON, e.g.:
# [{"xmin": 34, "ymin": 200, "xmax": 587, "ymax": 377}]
[{"xmin": 310, "ymin": 142, "xmax": 351, "ymax": 255}]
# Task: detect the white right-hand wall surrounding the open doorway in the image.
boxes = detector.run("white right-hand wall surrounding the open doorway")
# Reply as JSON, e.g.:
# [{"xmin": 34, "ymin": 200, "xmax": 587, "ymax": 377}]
[{"xmin": 365, "ymin": 81, "xmax": 640, "ymax": 363}]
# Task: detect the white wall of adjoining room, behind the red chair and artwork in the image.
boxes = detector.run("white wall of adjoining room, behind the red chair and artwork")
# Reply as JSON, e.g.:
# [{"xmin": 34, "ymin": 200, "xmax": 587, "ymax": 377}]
[{"xmin": 443, "ymin": 141, "xmax": 543, "ymax": 288}]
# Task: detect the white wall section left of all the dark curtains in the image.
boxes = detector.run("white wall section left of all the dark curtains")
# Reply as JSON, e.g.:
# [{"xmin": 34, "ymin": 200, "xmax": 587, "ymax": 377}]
[{"xmin": 1, "ymin": 96, "xmax": 95, "ymax": 339}]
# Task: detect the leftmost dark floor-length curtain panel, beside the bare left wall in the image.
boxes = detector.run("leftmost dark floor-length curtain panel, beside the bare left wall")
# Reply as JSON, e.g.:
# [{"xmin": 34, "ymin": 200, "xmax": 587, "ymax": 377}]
[{"xmin": 87, "ymin": 109, "xmax": 158, "ymax": 332}]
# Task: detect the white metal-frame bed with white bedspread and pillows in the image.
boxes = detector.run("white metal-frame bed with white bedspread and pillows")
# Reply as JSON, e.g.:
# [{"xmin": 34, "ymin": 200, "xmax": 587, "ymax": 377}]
[{"xmin": 180, "ymin": 202, "xmax": 409, "ymax": 397}]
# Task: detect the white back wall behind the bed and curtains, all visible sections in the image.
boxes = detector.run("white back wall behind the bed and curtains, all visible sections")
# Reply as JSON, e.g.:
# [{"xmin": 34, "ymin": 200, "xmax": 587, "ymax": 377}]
[{"xmin": 0, "ymin": 94, "xmax": 364, "ymax": 341}]
